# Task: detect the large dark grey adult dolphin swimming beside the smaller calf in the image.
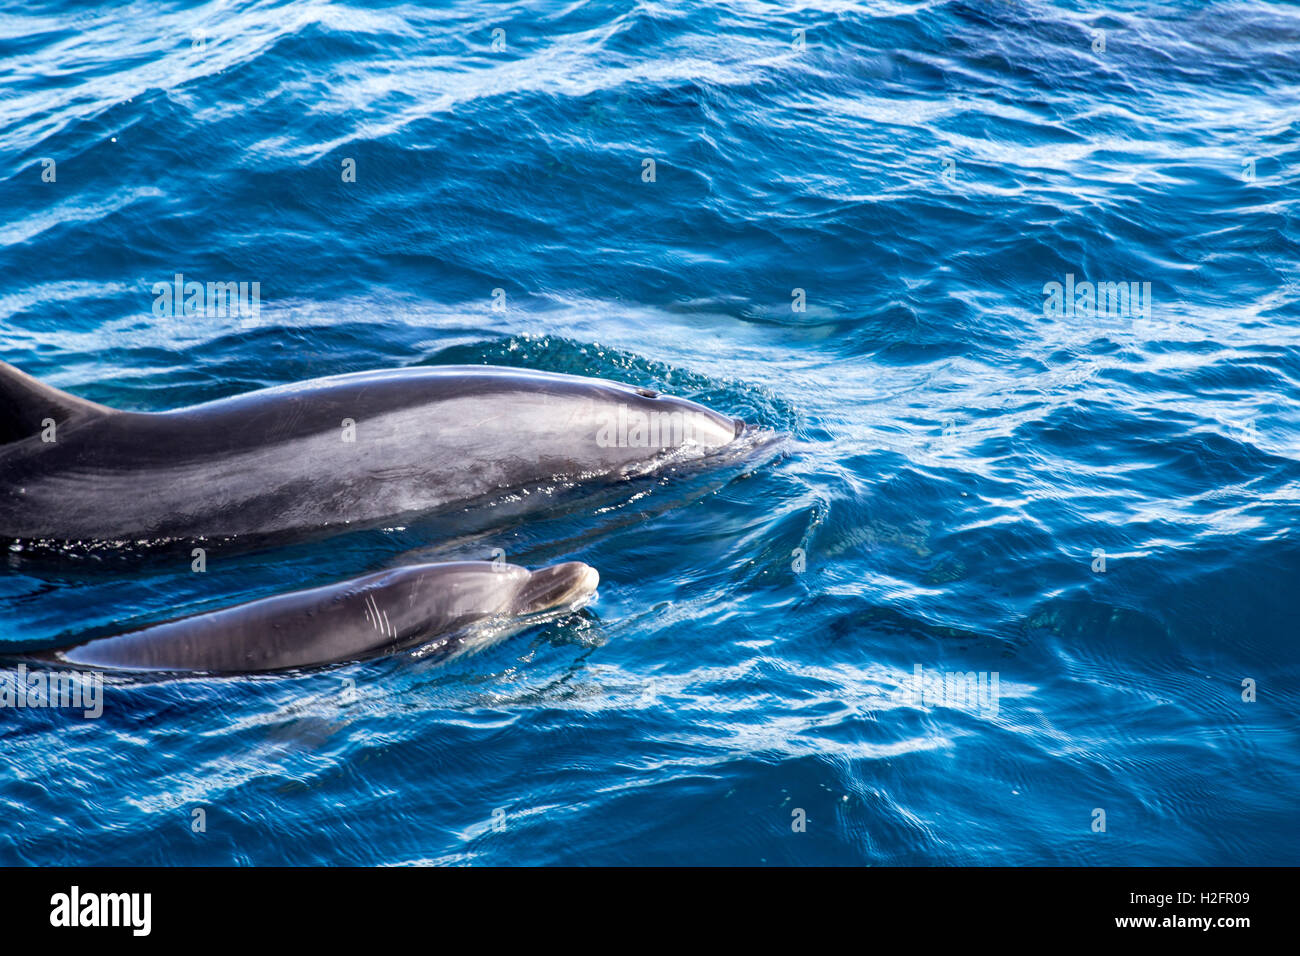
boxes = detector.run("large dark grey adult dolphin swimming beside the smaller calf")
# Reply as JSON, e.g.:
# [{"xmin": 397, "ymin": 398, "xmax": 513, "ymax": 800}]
[{"xmin": 0, "ymin": 363, "xmax": 744, "ymax": 544}]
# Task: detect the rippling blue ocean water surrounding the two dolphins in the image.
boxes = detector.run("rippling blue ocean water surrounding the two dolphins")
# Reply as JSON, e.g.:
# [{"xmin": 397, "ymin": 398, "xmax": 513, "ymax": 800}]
[{"xmin": 0, "ymin": 0, "xmax": 1300, "ymax": 865}]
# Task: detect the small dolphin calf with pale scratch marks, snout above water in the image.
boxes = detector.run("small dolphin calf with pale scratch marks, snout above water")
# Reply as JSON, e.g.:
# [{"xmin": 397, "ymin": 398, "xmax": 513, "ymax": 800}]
[{"xmin": 40, "ymin": 561, "xmax": 599, "ymax": 674}]
